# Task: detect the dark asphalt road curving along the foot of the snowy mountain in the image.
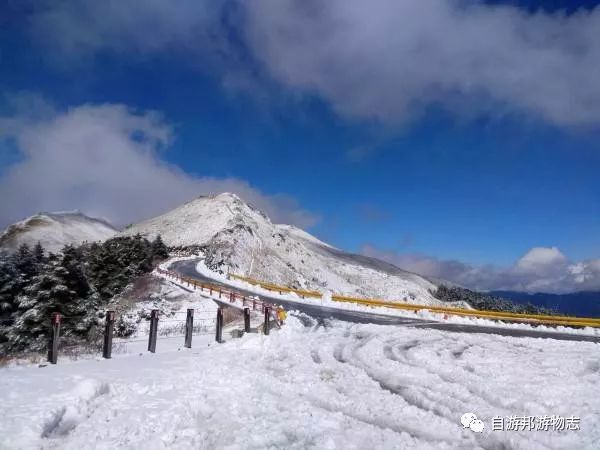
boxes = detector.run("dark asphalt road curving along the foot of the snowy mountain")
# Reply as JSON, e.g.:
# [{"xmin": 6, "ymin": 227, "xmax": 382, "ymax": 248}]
[{"xmin": 169, "ymin": 260, "xmax": 600, "ymax": 343}]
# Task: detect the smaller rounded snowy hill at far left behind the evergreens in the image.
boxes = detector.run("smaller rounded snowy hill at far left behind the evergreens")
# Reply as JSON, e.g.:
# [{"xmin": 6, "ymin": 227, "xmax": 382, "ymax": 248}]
[{"xmin": 0, "ymin": 211, "xmax": 117, "ymax": 253}]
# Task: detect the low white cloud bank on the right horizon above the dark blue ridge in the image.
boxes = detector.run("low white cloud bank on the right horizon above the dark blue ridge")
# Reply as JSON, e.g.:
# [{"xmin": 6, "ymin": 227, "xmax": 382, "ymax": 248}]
[{"xmin": 361, "ymin": 245, "xmax": 600, "ymax": 293}]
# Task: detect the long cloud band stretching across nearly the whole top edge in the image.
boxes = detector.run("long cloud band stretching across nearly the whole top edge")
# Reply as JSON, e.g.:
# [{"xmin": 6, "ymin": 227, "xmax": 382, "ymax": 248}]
[{"xmin": 19, "ymin": 0, "xmax": 600, "ymax": 126}]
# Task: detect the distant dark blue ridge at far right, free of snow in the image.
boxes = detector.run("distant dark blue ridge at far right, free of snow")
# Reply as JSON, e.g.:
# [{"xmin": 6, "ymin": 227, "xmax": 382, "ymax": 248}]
[{"xmin": 490, "ymin": 291, "xmax": 600, "ymax": 317}]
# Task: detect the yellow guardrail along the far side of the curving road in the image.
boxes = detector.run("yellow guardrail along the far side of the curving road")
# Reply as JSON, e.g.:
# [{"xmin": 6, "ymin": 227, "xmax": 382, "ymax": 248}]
[{"xmin": 229, "ymin": 273, "xmax": 600, "ymax": 328}]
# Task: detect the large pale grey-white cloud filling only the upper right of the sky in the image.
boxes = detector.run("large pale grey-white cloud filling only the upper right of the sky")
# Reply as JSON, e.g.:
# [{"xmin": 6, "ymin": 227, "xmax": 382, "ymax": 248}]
[{"xmin": 241, "ymin": 0, "xmax": 600, "ymax": 125}]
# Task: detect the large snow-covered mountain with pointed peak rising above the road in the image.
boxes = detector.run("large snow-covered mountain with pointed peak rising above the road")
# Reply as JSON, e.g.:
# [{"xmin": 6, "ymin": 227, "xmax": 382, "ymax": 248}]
[{"xmin": 122, "ymin": 193, "xmax": 448, "ymax": 304}]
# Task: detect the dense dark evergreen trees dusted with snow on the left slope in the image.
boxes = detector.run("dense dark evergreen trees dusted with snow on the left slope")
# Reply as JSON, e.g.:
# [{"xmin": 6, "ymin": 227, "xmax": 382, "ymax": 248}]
[{"xmin": 0, "ymin": 235, "xmax": 164, "ymax": 351}]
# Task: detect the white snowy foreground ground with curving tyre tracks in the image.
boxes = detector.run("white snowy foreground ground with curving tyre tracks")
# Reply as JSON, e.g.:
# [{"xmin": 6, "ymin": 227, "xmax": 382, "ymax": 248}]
[{"xmin": 0, "ymin": 317, "xmax": 600, "ymax": 450}]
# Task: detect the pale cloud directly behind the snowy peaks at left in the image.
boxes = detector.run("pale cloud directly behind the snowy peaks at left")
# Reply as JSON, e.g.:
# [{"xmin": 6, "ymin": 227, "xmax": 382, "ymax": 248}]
[{"xmin": 0, "ymin": 104, "xmax": 317, "ymax": 227}]
